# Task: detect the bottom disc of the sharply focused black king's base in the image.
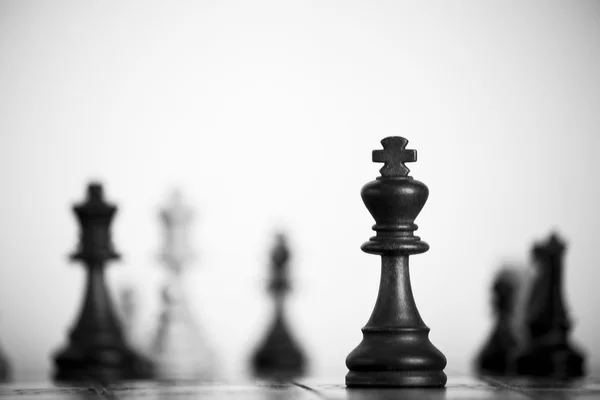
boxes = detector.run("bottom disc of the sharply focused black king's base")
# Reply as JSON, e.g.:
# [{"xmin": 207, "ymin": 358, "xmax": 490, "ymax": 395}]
[{"xmin": 346, "ymin": 371, "xmax": 447, "ymax": 388}]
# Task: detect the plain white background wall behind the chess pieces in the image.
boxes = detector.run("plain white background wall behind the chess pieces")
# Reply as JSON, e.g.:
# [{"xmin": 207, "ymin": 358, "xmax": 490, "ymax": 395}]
[{"xmin": 0, "ymin": 0, "xmax": 600, "ymax": 382}]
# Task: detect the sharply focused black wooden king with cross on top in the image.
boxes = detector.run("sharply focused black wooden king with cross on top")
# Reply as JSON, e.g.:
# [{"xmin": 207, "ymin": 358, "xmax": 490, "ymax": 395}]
[{"xmin": 346, "ymin": 137, "xmax": 446, "ymax": 387}]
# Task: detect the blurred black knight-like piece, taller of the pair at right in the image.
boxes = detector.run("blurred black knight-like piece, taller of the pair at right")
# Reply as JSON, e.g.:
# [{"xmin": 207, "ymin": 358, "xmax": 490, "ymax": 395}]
[{"xmin": 516, "ymin": 233, "xmax": 584, "ymax": 379}]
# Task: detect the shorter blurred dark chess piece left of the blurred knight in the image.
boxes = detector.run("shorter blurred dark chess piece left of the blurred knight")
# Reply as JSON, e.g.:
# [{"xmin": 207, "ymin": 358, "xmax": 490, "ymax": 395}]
[{"xmin": 475, "ymin": 268, "xmax": 520, "ymax": 376}]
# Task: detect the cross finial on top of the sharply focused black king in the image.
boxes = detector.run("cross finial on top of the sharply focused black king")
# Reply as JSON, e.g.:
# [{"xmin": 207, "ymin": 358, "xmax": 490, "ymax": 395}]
[{"xmin": 373, "ymin": 136, "xmax": 417, "ymax": 177}]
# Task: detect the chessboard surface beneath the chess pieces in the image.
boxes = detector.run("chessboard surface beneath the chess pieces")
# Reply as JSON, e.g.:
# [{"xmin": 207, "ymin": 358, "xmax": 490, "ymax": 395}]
[{"xmin": 0, "ymin": 375, "xmax": 600, "ymax": 400}]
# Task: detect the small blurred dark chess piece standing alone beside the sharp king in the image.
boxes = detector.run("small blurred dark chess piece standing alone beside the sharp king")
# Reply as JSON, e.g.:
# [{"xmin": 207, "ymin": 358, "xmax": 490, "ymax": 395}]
[{"xmin": 252, "ymin": 234, "xmax": 306, "ymax": 380}]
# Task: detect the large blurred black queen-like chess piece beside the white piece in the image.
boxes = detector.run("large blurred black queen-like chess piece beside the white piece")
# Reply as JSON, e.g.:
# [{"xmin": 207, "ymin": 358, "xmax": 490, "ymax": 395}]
[{"xmin": 54, "ymin": 183, "xmax": 152, "ymax": 381}]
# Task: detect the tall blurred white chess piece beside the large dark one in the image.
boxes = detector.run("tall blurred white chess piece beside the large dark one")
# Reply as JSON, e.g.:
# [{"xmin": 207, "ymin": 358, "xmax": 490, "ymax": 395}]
[{"xmin": 152, "ymin": 191, "xmax": 215, "ymax": 380}]
